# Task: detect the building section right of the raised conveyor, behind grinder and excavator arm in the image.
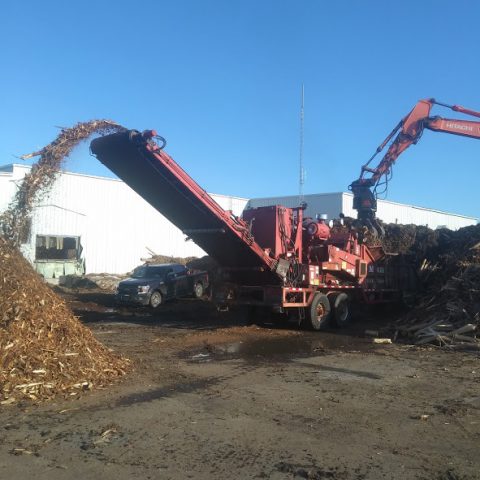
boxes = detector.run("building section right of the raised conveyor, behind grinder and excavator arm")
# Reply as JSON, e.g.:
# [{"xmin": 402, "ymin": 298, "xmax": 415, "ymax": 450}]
[{"xmin": 247, "ymin": 192, "xmax": 478, "ymax": 230}]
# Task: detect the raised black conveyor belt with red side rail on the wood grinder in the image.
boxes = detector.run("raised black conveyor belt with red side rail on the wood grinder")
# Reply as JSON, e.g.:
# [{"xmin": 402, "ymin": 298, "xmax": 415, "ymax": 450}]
[{"xmin": 90, "ymin": 130, "xmax": 282, "ymax": 285}]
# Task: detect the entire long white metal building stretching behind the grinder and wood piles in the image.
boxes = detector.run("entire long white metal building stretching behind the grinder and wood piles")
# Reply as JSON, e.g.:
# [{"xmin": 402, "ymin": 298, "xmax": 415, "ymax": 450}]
[{"xmin": 0, "ymin": 164, "xmax": 477, "ymax": 278}]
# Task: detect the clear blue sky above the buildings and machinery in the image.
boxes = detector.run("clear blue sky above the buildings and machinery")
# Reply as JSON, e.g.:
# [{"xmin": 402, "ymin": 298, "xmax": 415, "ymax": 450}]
[{"xmin": 0, "ymin": 0, "xmax": 480, "ymax": 217}]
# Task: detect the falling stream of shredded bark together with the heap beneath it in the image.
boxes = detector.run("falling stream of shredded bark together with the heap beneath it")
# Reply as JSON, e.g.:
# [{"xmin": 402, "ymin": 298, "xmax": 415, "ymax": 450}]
[{"xmin": 0, "ymin": 120, "xmax": 129, "ymax": 404}]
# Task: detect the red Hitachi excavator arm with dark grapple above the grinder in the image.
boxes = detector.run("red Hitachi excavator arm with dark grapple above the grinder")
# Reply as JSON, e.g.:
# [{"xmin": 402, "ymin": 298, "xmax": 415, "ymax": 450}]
[{"xmin": 349, "ymin": 98, "xmax": 480, "ymax": 233}]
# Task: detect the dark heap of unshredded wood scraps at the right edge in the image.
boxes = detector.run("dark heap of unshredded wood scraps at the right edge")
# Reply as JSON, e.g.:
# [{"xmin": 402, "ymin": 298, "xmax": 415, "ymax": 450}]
[{"xmin": 395, "ymin": 225, "xmax": 480, "ymax": 346}]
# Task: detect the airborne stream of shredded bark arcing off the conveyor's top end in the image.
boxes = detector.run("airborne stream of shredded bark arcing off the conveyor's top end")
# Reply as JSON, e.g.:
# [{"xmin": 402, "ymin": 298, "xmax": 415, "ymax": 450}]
[{"xmin": 0, "ymin": 120, "xmax": 124, "ymax": 245}]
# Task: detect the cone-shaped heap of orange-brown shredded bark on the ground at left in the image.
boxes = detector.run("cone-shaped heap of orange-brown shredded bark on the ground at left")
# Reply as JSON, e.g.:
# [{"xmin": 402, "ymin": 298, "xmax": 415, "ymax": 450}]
[{"xmin": 0, "ymin": 237, "xmax": 129, "ymax": 404}]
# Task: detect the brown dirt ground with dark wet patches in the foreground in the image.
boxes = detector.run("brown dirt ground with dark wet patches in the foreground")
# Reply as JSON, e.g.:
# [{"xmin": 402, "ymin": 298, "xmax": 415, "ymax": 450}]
[{"xmin": 0, "ymin": 292, "xmax": 480, "ymax": 480}]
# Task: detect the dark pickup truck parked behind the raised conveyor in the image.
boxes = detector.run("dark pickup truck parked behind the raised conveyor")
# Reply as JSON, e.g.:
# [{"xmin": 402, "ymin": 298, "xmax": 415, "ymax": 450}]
[{"xmin": 115, "ymin": 263, "xmax": 208, "ymax": 308}]
